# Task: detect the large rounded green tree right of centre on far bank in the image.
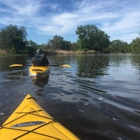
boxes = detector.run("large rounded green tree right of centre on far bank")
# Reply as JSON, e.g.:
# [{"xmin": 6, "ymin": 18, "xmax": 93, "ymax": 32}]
[{"xmin": 76, "ymin": 25, "xmax": 110, "ymax": 51}]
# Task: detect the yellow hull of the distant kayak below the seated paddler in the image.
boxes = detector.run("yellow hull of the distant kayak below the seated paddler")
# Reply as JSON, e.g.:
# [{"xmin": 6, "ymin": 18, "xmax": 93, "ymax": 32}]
[{"xmin": 29, "ymin": 66, "xmax": 50, "ymax": 77}]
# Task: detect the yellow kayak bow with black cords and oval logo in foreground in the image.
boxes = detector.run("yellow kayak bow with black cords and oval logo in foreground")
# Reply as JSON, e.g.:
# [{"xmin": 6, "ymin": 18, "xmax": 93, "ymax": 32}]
[{"xmin": 0, "ymin": 94, "xmax": 79, "ymax": 140}]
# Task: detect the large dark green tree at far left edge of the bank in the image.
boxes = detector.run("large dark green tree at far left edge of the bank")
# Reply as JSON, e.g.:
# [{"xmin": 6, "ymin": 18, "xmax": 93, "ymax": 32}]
[{"xmin": 0, "ymin": 24, "xmax": 27, "ymax": 54}]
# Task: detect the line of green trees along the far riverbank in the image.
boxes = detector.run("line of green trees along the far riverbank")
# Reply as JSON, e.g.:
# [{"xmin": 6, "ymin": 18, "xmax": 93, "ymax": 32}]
[{"xmin": 0, "ymin": 24, "xmax": 140, "ymax": 55}]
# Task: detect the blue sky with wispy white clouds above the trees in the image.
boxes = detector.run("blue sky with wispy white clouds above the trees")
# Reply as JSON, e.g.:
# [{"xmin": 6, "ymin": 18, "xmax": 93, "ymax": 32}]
[{"xmin": 0, "ymin": 0, "xmax": 140, "ymax": 44}]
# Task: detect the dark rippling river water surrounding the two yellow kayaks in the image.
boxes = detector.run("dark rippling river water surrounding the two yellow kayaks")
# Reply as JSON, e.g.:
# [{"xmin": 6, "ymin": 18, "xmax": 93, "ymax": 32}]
[{"xmin": 0, "ymin": 54, "xmax": 140, "ymax": 140}]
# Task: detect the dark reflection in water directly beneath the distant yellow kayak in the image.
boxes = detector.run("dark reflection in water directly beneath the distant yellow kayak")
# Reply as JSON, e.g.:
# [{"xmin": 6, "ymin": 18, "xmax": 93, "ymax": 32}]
[{"xmin": 31, "ymin": 75, "xmax": 49, "ymax": 87}]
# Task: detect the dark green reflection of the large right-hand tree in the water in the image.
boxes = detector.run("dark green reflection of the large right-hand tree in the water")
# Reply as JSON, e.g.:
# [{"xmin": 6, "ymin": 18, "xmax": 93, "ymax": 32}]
[{"xmin": 77, "ymin": 55, "xmax": 109, "ymax": 78}]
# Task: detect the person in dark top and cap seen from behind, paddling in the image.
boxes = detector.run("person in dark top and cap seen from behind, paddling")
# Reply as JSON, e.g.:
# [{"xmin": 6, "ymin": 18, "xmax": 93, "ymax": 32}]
[{"xmin": 31, "ymin": 49, "xmax": 49, "ymax": 66}]
